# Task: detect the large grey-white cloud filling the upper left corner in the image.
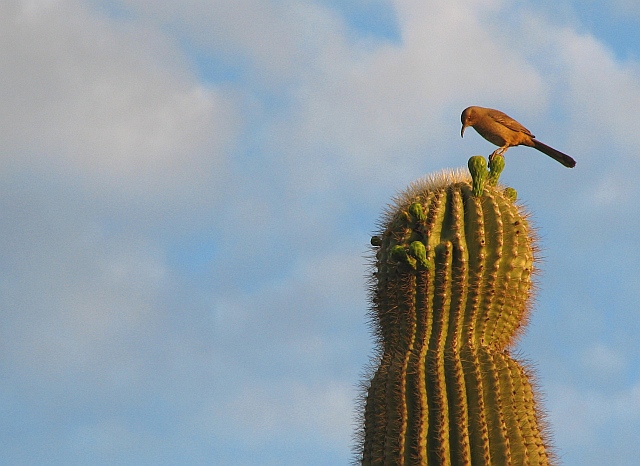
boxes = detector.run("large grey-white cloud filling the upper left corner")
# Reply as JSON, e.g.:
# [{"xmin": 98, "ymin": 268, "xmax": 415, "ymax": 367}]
[{"xmin": 0, "ymin": 0, "xmax": 239, "ymax": 197}]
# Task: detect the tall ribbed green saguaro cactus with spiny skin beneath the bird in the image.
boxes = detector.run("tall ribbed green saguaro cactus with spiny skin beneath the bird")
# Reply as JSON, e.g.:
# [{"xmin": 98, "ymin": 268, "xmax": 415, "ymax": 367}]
[{"xmin": 357, "ymin": 169, "xmax": 553, "ymax": 466}]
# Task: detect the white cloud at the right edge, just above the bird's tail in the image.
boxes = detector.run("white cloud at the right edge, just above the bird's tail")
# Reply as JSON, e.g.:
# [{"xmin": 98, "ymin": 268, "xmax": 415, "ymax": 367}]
[{"xmin": 523, "ymin": 13, "xmax": 640, "ymax": 157}]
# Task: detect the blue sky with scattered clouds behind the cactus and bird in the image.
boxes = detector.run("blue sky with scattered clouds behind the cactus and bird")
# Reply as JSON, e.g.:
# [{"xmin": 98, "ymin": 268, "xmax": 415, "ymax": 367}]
[{"xmin": 0, "ymin": 0, "xmax": 640, "ymax": 466}]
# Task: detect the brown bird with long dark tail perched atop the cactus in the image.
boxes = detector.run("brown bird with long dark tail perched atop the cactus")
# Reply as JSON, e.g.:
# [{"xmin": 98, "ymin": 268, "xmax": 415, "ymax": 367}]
[{"xmin": 460, "ymin": 107, "xmax": 576, "ymax": 168}]
